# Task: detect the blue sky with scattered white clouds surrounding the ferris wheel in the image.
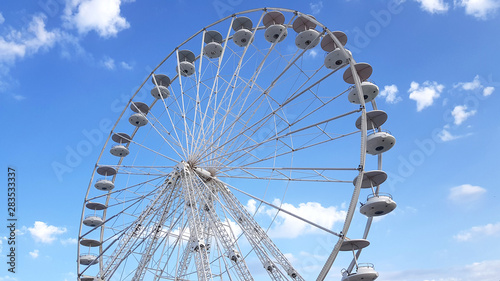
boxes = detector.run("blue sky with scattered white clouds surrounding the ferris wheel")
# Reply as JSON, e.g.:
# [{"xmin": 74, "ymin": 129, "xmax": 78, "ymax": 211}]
[{"xmin": 0, "ymin": 0, "xmax": 500, "ymax": 281}]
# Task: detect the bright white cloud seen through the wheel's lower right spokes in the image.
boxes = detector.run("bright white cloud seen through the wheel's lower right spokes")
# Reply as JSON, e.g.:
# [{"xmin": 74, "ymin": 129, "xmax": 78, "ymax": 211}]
[{"xmin": 266, "ymin": 199, "xmax": 346, "ymax": 238}]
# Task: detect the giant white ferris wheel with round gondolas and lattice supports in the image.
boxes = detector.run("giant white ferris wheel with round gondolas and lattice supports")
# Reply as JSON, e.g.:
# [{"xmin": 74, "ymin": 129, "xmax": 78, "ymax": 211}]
[{"xmin": 77, "ymin": 8, "xmax": 396, "ymax": 281}]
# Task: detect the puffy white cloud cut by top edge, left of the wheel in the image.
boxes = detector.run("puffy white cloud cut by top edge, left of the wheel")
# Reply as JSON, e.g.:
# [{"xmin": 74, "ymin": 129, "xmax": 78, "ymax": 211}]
[{"xmin": 63, "ymin": 0, "xmax": 130, "ymax": 37}]
